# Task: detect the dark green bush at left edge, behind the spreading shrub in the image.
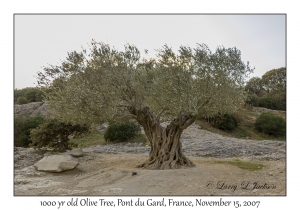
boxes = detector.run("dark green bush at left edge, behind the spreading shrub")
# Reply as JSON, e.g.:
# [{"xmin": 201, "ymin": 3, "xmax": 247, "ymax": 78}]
[{"xmin": 14, "ymin": 115, "xmax": 45, "ymax": 147}]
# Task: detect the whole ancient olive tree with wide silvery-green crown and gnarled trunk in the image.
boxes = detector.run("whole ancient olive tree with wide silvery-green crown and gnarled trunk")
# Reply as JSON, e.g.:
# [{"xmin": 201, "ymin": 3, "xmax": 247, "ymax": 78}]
[{"xmin": 38, "ymin": 40, "xmax": 252, "ymax": 169}]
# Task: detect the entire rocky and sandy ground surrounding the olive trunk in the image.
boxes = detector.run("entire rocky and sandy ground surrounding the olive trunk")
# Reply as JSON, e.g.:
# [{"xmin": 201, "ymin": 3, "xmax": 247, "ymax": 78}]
[{"xmin": 14, "ymin": 124, "xmax": 286, "ymax": 195}]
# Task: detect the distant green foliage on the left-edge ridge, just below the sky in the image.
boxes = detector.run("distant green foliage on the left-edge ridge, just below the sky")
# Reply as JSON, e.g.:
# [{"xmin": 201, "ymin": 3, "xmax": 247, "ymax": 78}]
[{"xmin": 14, "ymin": 87, "xmax": 44, "ymax": 104}]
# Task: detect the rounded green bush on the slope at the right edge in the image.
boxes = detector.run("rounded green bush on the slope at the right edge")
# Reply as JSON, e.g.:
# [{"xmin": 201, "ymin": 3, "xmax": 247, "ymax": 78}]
[{"xmin": 254, "ymin": 113, "xmax": 286, "ymax": 136}]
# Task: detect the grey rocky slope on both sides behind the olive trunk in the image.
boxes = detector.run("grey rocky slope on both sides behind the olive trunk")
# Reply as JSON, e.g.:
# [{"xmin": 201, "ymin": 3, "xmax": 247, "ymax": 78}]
[{"xmin": 83, "ymin": 124, "xmax": 286, "ymax": 161}]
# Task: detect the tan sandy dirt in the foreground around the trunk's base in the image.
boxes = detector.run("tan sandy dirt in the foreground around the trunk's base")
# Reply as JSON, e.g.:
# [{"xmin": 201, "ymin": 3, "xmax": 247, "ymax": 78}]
[{"xmin": 14, "ymin": 153, "xmax": 286, "ymax": 196}]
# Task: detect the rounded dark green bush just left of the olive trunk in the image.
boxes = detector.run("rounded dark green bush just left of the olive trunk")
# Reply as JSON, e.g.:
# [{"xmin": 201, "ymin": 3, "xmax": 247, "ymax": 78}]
[{"xmin": 104, "ymin": 122, "xmax": 140, "ymax": 142}]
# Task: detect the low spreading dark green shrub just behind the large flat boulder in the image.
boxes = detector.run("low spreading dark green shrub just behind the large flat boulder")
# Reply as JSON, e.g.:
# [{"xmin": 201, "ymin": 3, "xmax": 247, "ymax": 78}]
[{"xmin": 30, "ymin": 119, "xmax": 89, "ymax": 152}]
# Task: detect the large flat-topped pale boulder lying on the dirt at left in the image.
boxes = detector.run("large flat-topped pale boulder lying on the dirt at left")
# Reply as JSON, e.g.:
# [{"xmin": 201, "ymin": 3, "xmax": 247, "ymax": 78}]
[{"xmin": 34, "ymin": 154, "xmax": 79, "ymax": 172}]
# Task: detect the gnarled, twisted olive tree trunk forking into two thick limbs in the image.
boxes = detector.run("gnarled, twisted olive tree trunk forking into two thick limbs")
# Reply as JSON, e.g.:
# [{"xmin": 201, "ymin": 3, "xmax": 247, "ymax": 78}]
[{"xmin": 129, "ymin": 107, "xmax": 195, "ymax": 169}]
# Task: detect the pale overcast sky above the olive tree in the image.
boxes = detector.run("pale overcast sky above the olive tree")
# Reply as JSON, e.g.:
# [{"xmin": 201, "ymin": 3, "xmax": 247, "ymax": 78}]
[{"xmin": 14, "ymin": 13, "xmax": 286, "ymax": 89}]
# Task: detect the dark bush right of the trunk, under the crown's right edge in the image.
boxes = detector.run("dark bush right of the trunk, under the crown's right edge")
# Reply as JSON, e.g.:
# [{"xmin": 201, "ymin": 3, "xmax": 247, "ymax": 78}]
[{"xmin": 209, "ymin": 114, "xmax": 238, "ymax": 131}]
